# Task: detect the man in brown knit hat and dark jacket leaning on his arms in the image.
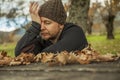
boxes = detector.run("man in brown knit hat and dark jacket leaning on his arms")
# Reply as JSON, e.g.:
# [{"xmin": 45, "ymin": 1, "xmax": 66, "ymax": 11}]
[{"xmin": 15, "ymin": 0, "xmax": 88, "ymax": 56}]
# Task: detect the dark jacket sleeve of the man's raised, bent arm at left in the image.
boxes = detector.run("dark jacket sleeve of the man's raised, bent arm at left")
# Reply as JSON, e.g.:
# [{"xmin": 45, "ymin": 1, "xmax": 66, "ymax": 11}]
[{"xmin": 15, "ymin": 21, "xmax": 41, "ymax": 56}]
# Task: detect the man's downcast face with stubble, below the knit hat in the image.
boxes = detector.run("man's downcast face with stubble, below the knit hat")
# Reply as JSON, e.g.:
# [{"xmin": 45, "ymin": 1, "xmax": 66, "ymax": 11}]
[{"xmin": 40, "ymin": 17, "xmax": 63, "ymax": 40}]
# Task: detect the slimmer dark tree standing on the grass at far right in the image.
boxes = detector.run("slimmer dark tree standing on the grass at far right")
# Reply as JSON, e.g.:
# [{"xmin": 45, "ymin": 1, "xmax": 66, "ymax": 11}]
[{"xmin": 104, "ymin": 0, "xmax": 120, "ymax": 39}]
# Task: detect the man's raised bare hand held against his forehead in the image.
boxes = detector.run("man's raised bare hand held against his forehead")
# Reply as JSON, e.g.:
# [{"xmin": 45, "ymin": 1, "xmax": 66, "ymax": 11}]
[{"xmin": 29, "ymin": 2, "xmax": 41, "ymax": 24}]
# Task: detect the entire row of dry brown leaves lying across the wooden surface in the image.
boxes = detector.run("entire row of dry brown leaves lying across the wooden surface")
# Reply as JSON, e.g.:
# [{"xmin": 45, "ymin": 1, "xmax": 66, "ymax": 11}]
[{"xmin": 0, "ymin": 45, "xmax": 120, "ymax": 66}]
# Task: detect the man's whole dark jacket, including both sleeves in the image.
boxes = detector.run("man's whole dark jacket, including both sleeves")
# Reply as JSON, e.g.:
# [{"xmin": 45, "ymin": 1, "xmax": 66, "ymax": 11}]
[{"xmin": 15, "ymin": 22, "xmax": 88, "ymax": 56}]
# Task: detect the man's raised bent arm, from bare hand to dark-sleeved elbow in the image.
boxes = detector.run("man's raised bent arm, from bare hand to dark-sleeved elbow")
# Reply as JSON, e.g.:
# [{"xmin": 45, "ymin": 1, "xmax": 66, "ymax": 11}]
[{"xmin": 15, "ymin": 2, "xmax": 41, "ymax": 56}]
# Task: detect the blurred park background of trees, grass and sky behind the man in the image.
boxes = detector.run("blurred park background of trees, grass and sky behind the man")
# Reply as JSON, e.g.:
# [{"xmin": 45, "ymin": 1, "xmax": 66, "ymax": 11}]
[{"xmin": 0, "ymin": 0, "xmax": 120, "ymax": 57}]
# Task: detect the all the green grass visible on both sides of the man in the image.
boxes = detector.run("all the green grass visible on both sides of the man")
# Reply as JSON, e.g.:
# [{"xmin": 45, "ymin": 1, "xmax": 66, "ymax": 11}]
[{"xmin": 0, "ymin": 34, "xmax": 120, "ymax": 57}]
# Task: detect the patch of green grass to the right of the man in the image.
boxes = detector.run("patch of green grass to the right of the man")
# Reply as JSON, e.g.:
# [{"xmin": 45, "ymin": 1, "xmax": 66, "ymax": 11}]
[{"xmin": 87, "ymin": 34, "xmax": 120, "ymax": 54}]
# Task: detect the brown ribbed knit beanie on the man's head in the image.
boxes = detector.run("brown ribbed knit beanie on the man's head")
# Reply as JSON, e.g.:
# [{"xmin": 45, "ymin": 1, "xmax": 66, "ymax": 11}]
[{"xmin": 39, "ymin": 0, "xmax": 67, "ymax": 24}]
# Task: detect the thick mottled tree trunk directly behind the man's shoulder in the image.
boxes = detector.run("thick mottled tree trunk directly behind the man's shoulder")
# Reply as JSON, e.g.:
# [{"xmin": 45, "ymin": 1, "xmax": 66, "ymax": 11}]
[{"xmin": 67, "ymin": 0, "xmax": 90, "ymax": 32}]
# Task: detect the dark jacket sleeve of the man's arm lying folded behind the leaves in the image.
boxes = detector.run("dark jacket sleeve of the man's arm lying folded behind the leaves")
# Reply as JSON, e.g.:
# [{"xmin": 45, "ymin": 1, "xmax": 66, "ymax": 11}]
[{"xmin": 42, "ymin": 27, "xmax": 88, "ymax": 53}]
